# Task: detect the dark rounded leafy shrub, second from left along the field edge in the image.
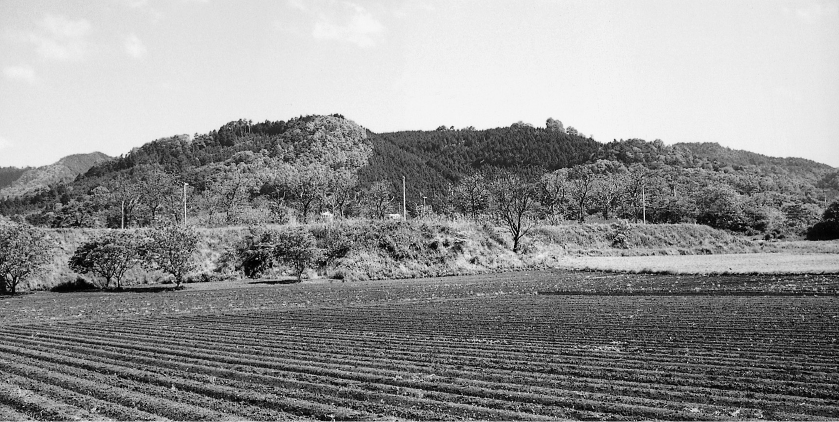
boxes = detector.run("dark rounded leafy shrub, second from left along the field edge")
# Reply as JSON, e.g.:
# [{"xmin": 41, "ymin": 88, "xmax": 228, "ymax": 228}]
[{"xmin": 68, "ymin": 231, "xmax": 141, "ymax": 289}]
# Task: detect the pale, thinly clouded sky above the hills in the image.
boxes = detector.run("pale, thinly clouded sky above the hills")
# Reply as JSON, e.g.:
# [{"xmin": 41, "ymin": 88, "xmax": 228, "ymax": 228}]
[{"xmin": 0, "ymin": 0, "xmax": 839, "ymax": 167}]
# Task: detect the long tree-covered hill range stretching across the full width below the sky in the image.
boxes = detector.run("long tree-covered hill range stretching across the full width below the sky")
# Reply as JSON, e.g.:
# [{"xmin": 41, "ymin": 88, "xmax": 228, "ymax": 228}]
[{"xmin": 0, "ymin": 114, "xmax": 839, "ymax": 231}]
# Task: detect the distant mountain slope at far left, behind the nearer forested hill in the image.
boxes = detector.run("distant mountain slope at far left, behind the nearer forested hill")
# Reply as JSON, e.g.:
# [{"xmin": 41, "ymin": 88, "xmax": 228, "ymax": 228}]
[{"xmin": 0, "ymin": 152, "xmax": 111, "ymax": 198}]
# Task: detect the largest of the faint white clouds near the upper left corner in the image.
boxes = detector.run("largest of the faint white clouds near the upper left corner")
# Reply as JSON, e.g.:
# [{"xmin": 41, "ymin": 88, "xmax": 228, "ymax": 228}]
[{"xmin": 23, "ymin": 15, "xmax": 90, "ymax": 61}]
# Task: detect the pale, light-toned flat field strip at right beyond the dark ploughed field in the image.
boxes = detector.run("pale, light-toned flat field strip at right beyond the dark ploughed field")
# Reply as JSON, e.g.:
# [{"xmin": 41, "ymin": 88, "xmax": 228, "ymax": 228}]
[{"xmin": 561, "ymin": 253, "xmax": 839, "ymax": 274}]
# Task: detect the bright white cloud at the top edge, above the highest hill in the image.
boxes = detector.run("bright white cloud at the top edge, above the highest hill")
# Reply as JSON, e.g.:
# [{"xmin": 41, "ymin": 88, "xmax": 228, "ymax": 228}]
[{"xmin": 312, "ymin": 2, "xmax": 385, "ymax": 48}]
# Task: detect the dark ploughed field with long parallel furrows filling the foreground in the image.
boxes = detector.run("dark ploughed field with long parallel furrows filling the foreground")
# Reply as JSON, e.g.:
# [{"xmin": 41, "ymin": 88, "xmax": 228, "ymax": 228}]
[{"xmin": 0, "ymin": 271, "xmax": 839, "ymax": 421}]
